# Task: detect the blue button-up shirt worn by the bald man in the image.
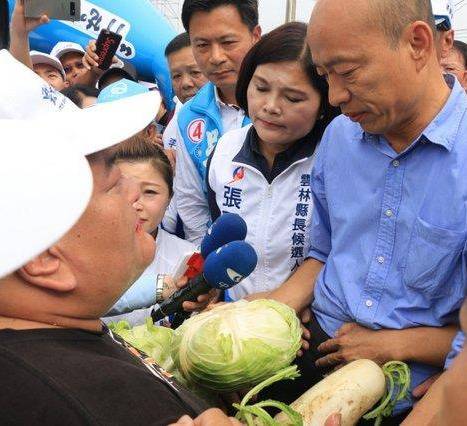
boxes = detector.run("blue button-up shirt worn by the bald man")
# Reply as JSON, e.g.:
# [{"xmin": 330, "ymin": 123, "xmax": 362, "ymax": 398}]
[{"xmin": 309, "ymin": 79, "xmax": 467, "ymax": 410}]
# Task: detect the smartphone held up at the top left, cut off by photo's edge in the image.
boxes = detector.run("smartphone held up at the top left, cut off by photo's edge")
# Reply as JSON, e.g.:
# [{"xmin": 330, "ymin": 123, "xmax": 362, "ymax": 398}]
[{"xmin": 24, "ymin": 0, "xmax": 81, "ymax": 21}]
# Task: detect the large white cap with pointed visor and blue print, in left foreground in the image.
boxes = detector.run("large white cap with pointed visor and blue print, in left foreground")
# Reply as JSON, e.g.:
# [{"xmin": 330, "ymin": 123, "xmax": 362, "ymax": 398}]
[{"xmin": 0, "ymin": 50, "xmax": 161, "ymax": 155}]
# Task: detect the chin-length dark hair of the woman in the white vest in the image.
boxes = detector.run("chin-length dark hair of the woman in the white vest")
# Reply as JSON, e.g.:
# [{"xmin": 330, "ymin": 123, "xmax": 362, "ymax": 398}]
[{"xmin": 235, "ymin": 22, "xmax": 340, "ymax": 140}]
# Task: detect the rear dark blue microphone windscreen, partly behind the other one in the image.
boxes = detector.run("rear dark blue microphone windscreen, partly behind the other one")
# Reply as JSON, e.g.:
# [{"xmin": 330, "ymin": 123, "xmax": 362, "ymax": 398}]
[{"xmin": 201, "ymin": 213, "xmax": 247, "ymax": 259}]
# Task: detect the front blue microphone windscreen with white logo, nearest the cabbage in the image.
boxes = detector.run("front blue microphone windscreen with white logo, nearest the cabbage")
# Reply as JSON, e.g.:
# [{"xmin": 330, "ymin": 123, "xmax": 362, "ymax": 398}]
[{"xmin": 203, "ymin": 241, "xmax": 258, "ymax": 290}]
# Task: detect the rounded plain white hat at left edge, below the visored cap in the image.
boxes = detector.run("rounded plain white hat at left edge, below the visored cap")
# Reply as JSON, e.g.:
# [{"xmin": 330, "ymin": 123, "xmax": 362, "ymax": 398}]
[{"xmin": 0, "ymin": 120, "xmax": 92, "ymax": 278}]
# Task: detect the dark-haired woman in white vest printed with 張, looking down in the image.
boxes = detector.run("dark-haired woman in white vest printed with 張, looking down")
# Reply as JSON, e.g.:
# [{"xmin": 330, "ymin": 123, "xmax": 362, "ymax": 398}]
[{"xmin": 207, "ymin": 22, "xmax": 337, "ymax": 300}]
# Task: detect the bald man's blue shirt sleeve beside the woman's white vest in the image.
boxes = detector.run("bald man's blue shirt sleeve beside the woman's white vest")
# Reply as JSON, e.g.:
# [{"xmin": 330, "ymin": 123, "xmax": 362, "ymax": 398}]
[{"xmin": 308, "ymin": 131, "xmax": 331, "ymax": 263}]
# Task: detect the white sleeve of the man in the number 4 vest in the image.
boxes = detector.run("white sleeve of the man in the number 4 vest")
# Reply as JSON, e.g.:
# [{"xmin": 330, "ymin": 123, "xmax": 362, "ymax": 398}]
[{"xmin": 174, "ymin": 125, "xmax": 210, "ymax": 245}]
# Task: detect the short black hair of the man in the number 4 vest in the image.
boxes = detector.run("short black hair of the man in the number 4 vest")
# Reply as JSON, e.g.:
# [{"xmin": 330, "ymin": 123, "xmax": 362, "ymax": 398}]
[{"xmin": 182, "ymin": 0, "xmax": 258, "ymax": 32}]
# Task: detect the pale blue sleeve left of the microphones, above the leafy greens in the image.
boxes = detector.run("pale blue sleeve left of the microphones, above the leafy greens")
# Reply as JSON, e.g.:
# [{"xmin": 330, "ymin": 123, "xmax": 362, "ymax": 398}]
[{"xmin": 107, "ymin": 271, "xmax": 156, "ymax": 315}]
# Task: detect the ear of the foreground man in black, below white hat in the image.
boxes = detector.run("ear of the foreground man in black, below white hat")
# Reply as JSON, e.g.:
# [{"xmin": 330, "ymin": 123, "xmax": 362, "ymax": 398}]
[{"xmin": 18, "ymin": 246, "xmax": 77, "ymax": 292}]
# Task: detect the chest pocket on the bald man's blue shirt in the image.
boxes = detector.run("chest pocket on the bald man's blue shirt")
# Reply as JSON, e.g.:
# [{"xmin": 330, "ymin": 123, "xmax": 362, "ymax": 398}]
[{"xmin": 403, "ymin": 218, "xmax": 466, "ymax": 296}]
